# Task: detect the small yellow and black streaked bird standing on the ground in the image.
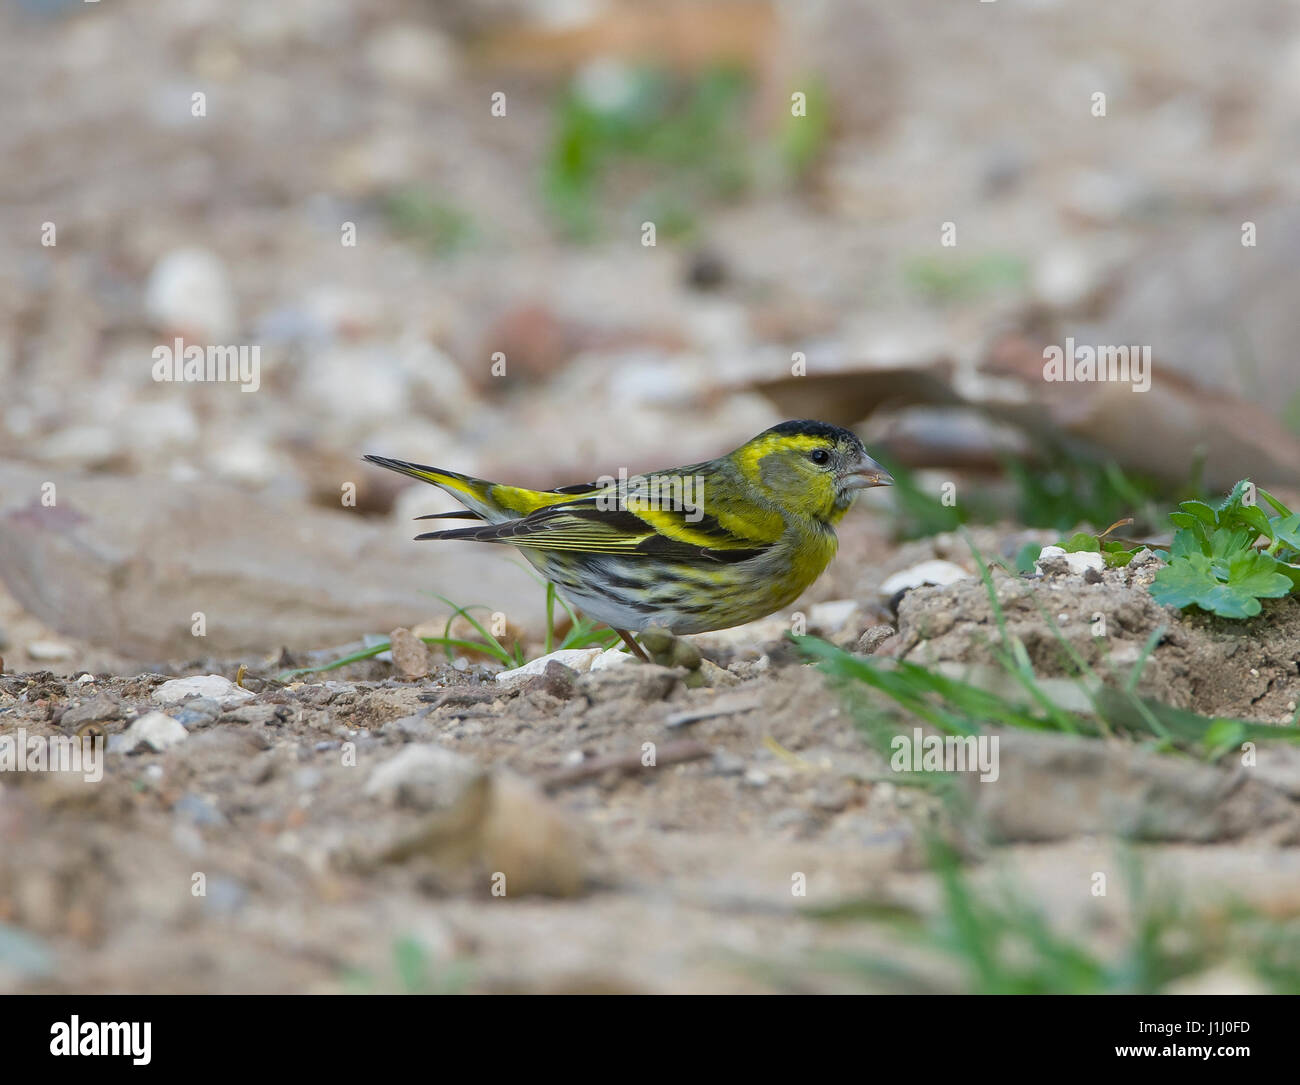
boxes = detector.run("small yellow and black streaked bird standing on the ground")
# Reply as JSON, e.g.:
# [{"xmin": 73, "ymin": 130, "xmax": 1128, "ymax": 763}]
[{"xmin": 364, "ymin": 420, "xmax": 893, "ymax": 660}]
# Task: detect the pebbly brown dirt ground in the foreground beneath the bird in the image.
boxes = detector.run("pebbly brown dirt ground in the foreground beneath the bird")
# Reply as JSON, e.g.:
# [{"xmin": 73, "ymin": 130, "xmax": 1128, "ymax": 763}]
[{"xmin": 0, "ymin": 533, "xmax": 1300, "ymax": 991}]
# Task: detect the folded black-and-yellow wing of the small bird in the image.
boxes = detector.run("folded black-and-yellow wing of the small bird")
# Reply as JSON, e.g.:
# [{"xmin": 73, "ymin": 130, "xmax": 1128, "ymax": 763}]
[{"xmin": 417, "ymin": 496, "xmax": 771, "ymax": 561}]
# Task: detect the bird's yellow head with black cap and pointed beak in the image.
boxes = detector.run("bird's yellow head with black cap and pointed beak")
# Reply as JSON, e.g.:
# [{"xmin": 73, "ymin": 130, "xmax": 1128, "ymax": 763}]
[{"xmin": 731, "ymin": 421, "xmax": 893, "ymax": 522}]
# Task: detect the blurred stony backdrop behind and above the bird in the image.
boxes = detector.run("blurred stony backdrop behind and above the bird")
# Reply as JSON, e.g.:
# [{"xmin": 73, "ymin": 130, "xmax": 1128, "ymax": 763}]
[{"xmin": 0, "ymin": 0, "xmax": 1300, "ymax": 661}]
